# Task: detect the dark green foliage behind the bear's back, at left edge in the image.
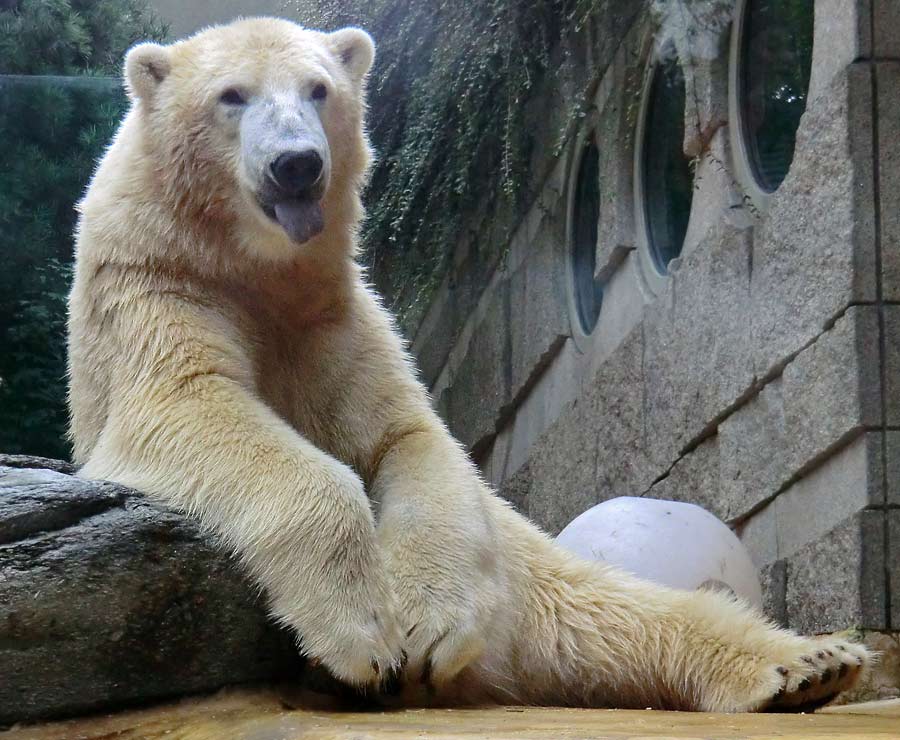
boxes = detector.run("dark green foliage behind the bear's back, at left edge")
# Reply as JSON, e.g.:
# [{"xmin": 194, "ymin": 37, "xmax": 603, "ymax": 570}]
[{"xmin": 0, "ymin": 0, "xmax": 165, "ymax": 458}]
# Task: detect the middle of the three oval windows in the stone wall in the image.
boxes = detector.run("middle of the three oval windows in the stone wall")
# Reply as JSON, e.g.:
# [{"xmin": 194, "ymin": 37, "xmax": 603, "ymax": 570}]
[{"xmin": 641, "ymin": 53, "xmax": 694, "ymax": 275}]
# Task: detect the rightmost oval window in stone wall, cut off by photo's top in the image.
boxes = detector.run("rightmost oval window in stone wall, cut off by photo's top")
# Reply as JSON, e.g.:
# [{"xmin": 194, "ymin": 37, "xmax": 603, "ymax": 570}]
[{"xmin": 738, "ymin": 0, "xmax": 814, "ymax": 193}]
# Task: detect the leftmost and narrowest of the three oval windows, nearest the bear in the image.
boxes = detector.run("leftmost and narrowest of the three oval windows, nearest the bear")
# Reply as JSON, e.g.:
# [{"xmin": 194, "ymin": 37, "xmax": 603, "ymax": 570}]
[{"xmin": 571, "ymin": 137, "xmax": 603, "ymax": 334}]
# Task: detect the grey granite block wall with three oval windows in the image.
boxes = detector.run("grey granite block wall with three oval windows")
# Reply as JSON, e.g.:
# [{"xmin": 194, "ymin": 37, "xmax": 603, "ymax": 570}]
[{"xmin": 412, "ymin": 0, "xmax": 900, "ymax": 632}]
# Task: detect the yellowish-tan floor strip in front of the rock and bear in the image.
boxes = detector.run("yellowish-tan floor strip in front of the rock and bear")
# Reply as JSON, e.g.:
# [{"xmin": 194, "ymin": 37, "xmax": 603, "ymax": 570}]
[{"xmin": 0, "ymin": 689, "xmax": 900, "ymax": 740}]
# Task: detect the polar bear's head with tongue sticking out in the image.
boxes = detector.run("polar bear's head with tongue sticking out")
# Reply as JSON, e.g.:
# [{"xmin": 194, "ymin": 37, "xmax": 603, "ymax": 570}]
[{"xmin": 125, "ymin": 18, "xmax": 374, "ymax": 258}]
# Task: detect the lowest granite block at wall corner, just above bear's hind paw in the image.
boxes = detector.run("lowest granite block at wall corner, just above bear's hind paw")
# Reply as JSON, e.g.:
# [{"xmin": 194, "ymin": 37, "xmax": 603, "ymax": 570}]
[{"xmin": 787, "ymin": 511, "xmax": 887, "ymax": 633}]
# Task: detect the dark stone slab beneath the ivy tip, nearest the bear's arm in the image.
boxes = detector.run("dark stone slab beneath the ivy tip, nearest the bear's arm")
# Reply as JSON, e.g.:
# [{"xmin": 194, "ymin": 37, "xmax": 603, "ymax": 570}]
[{"xmin": 442, "ymin": 281, "xmax": 511, "ymax": 451}]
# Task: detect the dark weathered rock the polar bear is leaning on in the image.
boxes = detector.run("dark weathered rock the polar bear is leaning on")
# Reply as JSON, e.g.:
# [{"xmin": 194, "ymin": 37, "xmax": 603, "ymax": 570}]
[{"xmin": 0, "ymin": 467, "xmax": 300, "ymax": 723}]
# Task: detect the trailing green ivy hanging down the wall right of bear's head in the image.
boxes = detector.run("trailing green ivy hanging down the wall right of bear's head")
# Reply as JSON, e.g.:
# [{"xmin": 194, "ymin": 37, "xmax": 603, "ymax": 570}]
[{"xmin": 288, "ymin": 0, "xmax": 642, "ymax": 328}]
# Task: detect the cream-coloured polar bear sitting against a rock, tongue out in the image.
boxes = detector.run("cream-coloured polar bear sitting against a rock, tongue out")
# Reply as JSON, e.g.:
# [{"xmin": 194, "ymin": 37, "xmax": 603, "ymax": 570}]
[{"xmin": 69, "ymin": 19, "xmax": 870, "ymax": 712}]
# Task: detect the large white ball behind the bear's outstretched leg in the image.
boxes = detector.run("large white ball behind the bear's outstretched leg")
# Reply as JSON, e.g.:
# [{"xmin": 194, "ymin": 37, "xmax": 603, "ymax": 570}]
[{"xmin": 556, "ymin": 496, "xmax": 762, "ymax": 607}]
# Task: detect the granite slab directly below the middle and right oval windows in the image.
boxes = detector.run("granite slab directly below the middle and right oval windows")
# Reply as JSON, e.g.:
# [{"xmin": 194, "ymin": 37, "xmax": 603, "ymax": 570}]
[{"xmin": 643, "ymin": 221, "xmax": 754, "ymax": 468}]
